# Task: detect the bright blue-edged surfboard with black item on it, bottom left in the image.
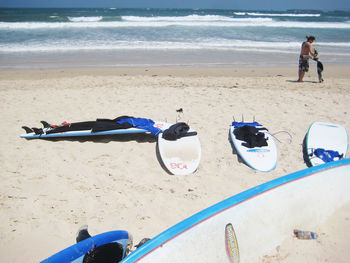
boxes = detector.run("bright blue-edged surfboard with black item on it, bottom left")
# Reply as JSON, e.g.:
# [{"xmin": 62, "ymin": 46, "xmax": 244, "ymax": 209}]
[{"xmin": 41, "ymin": 230, "xmax": 133, "ymax": 263}]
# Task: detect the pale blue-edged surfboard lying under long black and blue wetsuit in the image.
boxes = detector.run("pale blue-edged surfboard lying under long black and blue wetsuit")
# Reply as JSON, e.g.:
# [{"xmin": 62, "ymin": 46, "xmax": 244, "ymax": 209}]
[{"xmin": 20, "ymin": 121, "xmax": 164, "ymax": 139}]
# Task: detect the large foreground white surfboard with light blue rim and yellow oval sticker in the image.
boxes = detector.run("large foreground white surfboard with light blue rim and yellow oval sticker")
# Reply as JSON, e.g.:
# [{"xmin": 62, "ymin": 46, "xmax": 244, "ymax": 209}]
[{"xmin": 122, "ymin": 159, "xmax": 350, "ymax": 263}]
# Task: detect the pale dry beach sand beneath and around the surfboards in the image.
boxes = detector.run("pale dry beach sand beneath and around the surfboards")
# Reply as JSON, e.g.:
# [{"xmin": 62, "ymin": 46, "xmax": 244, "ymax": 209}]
[{"xmin": 0, "ymin": 66, "xmax": 350, "ymax": 262}]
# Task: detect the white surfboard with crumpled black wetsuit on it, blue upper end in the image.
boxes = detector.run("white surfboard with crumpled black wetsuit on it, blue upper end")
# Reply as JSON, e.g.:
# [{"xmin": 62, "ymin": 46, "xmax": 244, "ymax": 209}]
[{"xmin": 230, "ymin": 122, "xmax": 278, "ymax": 172}]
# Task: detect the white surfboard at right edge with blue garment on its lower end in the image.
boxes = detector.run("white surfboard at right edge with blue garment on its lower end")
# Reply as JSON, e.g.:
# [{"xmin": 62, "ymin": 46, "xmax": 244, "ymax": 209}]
[{"xmin": 305, "ymin": 122, "xmax": 349, "ymax": 166}]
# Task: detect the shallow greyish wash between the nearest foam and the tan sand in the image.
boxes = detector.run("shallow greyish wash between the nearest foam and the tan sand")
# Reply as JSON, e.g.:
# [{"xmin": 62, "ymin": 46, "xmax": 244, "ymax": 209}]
[{"xmin": 0, "ymin": 49, "xmax": 350, "ymax": 69}]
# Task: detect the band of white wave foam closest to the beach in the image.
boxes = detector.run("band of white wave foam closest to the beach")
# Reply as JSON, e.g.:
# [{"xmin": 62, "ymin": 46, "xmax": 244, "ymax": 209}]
[{"xmin": 0, "ymin": 38, "xmax": 350, "ymax": 55}]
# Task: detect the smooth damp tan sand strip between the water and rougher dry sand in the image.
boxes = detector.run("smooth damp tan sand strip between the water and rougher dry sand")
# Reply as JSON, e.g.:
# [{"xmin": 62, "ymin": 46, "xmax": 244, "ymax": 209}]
[{"xmin": 0, "ymin": 64, "xmax": 350, "ymax": 81}]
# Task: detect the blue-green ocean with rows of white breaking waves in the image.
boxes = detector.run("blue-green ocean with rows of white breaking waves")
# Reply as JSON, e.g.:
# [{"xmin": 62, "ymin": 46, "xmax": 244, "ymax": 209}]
[{"xmin": 0, "ymin": 8, "xmax": 350, "ymax": 68}]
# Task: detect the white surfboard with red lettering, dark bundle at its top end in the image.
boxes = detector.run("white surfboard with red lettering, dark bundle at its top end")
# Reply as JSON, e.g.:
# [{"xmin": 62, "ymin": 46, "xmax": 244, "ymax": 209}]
[{"xmin": 158, "ymin": 123, "xmax": 201, "ymax": 175}]
